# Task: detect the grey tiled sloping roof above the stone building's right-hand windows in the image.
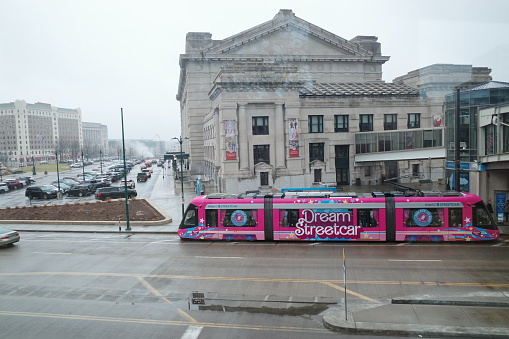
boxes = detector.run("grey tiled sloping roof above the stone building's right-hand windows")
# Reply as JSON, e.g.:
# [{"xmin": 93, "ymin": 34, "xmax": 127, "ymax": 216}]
[{"xmin": 300, "ymin": 82, "xmax": 419, "ymax": 97}]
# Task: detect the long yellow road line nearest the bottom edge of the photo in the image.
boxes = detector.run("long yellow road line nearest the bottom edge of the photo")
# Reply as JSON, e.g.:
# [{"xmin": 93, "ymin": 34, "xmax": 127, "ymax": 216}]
[{"xmin": 0, "ymin": 311, "xmax": 329, "ymax": 333}]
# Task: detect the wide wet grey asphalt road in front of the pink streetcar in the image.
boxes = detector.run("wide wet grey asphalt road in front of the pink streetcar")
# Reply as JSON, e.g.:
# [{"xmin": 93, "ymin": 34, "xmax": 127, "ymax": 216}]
[{"xmin": 0, "ymin": 233, "xmax": 509, "ymax": 339}]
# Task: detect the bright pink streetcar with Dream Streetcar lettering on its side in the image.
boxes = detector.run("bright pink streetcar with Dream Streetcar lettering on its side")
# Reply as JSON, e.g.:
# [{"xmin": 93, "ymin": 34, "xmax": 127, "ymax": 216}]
[{"xmin": 178, "ymin": 191, "xmax": 500, "ymax": 241}]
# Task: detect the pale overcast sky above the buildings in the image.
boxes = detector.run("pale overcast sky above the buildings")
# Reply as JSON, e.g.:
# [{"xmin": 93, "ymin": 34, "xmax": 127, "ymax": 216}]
[{"xmin": 0, "ymin": 0, "xmax": 509, "ymax": 140}]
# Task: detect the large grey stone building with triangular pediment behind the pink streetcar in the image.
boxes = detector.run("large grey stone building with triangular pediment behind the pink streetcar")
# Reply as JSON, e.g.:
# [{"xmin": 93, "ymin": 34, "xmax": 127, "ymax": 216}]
[{"xmin": 177, "ymin": 10, "xmax": 480, "ymax": 192}]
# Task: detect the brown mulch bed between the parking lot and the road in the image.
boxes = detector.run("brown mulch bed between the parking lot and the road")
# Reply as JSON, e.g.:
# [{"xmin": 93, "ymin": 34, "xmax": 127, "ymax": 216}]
[{"xmin": 0, "ymin": 199, "xmax": 165, "ymax": 221}]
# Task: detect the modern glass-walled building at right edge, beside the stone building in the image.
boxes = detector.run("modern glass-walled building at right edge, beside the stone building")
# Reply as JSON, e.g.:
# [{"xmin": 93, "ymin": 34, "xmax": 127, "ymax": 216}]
[{"xmin": 445, "ymin": 81, "xmax": 509, "ymax": 221}]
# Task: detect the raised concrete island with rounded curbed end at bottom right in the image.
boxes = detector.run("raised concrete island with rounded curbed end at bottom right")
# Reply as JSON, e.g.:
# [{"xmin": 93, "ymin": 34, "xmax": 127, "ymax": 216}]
[{"xmin": 323, "ymin": 293, "xmax": 509, "ymax": 338}]
